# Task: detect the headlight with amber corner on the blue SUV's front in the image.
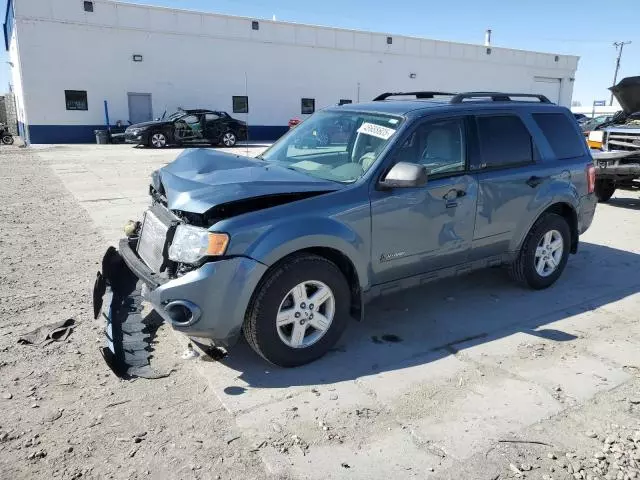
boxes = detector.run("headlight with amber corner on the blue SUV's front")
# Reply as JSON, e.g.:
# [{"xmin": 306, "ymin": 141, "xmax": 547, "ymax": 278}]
[{"xmin": 169, "ymin": 225, "xmax": 229, "ymax": 263}]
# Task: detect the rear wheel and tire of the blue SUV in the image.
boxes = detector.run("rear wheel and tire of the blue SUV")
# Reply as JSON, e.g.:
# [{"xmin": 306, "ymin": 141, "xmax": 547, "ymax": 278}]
[{"xmin": 510, "ymin": 213, "xmax": 571, "ymax": 290}]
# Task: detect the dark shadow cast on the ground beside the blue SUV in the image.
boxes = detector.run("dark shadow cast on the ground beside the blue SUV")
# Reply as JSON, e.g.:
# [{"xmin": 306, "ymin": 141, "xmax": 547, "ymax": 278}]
[{"xmin": 221, "ymin": 242, "xmax": 640, "ymax": 395}]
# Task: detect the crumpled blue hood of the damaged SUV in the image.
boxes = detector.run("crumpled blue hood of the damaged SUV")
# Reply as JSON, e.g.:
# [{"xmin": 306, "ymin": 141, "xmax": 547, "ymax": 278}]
[{"xmin": 158, "ymin": 149, "xmax": 343, "ymax": 214}]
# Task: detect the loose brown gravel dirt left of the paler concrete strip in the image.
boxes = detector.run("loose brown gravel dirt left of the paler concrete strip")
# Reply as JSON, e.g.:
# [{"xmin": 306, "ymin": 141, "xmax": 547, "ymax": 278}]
[{"xmin": 0, "ymin": 149, "xmax": 272, "ymax": 480}]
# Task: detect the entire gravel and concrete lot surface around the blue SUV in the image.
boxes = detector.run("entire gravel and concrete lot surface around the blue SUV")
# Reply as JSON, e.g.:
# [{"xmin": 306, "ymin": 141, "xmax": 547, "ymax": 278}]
[{"xmin": 0, "ymin": 146, "xmax": 640, "ymax": 480}]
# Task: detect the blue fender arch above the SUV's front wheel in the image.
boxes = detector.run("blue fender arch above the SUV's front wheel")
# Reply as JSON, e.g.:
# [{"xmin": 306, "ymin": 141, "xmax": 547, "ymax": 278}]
[{"xmin": 246, "ymin": 217, "xmax": 369, "ymax": 288}]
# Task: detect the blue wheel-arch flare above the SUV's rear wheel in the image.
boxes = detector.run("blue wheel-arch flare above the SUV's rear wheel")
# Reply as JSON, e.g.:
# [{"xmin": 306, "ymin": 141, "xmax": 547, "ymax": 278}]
[{"xmin": 509, "ymin": 179, "xmax": 580, "ymax": 252}]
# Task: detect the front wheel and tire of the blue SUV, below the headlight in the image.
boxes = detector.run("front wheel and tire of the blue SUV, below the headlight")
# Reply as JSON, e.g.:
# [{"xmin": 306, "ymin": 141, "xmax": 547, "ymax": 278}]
[{"xmin": 243, "ymin": 255, "xmax": 350, "ymax": 367}]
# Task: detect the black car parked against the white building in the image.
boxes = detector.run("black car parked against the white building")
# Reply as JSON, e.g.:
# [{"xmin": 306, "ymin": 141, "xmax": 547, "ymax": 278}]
[{"xmin": 125, "ymin": 109, "xmax": 247, "ymax": 148}]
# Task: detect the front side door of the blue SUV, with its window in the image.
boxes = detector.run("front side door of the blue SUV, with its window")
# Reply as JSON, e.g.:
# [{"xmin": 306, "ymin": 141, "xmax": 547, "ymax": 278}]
[{"xmin": 371, "ymin": 116, "xmax": 478, "ymax": 284}]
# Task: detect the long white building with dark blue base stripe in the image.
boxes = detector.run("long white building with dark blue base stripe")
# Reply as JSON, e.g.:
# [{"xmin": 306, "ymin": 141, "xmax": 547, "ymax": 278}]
[{"xmin": 5, "ymin": 0, "xmax": 578, "ymax": 143}]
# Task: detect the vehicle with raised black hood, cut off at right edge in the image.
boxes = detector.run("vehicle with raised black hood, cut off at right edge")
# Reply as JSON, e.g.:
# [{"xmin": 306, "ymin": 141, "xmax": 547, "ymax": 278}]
[{"xmin": 589, "ymin": 77, "xmax": 640, "ymax": 202}]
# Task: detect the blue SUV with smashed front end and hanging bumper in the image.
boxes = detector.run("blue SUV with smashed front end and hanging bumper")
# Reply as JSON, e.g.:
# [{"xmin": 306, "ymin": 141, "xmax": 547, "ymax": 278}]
[{"xmin": 94, "ymin": 92, "xmax": 596, "ymax": 367}]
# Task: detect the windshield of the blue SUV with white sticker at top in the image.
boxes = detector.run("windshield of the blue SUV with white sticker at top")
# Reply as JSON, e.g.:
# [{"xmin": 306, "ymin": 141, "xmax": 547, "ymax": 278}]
[{"xmin": 259, "ymin": 111, "xmax": 402, "ymax": 183}]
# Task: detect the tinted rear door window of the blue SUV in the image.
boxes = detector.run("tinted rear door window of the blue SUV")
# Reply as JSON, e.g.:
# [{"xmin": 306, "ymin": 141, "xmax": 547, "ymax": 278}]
[{"xmin": 477, "ymin": 115, "xmax": 533, "ymax": 168}]
